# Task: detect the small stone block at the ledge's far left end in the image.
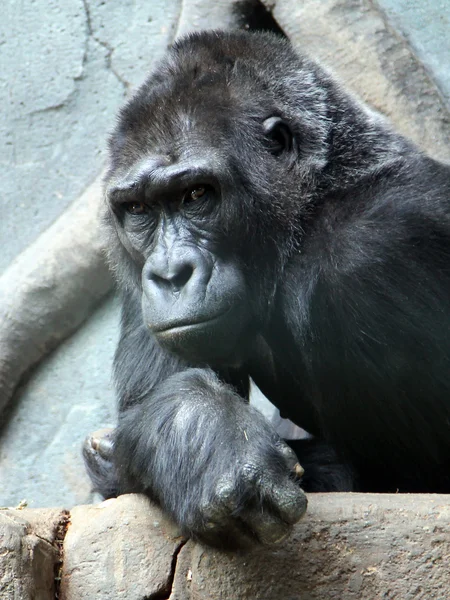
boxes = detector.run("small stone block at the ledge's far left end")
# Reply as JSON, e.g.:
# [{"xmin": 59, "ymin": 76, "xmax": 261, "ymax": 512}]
[{"xmin": 0, "ymin": 509, "xmax": 65, "ymax": 600}]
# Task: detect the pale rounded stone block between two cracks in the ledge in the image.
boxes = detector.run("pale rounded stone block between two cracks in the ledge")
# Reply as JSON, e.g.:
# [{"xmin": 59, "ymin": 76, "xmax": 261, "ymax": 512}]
[{"xmin": 60, "ymin": 495, "xmax": 185, "ymax": 600}]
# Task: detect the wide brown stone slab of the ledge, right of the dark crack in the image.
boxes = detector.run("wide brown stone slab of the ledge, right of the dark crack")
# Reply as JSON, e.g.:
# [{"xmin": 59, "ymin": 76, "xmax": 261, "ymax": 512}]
[{"xmin": 170, "ymin": 494, "xmax": 450, "ymax": 600}]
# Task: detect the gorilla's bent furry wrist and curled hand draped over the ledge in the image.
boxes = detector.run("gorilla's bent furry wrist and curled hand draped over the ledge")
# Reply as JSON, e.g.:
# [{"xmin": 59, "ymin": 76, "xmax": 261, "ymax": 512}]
[{"xmin": 115, "ymin": 369, "xmax": 307, "ymax": 548}]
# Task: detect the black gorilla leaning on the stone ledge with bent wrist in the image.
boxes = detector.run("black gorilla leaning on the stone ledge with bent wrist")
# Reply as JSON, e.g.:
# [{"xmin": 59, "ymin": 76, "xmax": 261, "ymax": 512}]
[{"xmin": 84, "ymin": 31, "xmax": 450, "ymax": 548}]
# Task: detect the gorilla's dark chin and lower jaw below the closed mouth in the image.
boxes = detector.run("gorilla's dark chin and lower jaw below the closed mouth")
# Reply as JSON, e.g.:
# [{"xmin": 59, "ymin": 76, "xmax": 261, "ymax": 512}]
[{"xmin": 150, "ymin": 303, "xmax": 254, "ymax": 366}]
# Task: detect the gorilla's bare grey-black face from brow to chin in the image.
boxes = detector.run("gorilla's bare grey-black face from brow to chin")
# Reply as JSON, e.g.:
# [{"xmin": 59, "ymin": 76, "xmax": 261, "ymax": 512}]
[{"xmin": 108, "ymin": 155, "xmax": 251, "ymax": 362}]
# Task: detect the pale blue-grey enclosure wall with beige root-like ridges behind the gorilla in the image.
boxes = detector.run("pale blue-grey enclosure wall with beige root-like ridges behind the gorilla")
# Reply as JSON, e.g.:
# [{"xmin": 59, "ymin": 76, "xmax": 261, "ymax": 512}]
[{"xmin": 0, "ymin": 0, "xmax": 450, "ymax": 506}]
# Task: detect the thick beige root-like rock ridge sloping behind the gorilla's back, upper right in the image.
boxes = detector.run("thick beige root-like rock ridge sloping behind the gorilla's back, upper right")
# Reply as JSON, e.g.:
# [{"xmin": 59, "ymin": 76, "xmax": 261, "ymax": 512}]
[{"xmin": 264, "ymin": 0, "xmax": 450, "ymax": 161}]
